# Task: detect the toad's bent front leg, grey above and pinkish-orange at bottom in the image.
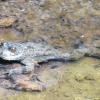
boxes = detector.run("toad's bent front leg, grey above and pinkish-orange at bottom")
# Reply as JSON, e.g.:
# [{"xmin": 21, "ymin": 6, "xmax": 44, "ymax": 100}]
[{"xmin": 9, "ymin": 59, "xmax": 44, "ymax": 91}]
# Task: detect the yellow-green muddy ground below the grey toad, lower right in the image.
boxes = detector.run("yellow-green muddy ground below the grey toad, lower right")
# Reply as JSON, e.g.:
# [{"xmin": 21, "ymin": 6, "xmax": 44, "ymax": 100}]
[{"xmin": 8, "ymin": 58, "xmax": 100, "ymax": 100}]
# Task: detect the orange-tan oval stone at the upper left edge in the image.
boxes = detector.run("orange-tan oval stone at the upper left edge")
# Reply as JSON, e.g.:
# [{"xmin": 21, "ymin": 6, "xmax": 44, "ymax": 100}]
[{"xmin": 0, "ymin": 17, "xmax": 16, "ymax": 27}]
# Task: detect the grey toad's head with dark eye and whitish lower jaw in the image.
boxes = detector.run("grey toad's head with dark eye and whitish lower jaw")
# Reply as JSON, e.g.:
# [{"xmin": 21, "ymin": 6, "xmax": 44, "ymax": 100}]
[{"xmin": 0, "ymin": 42, "xmax": 24, "ymax": 60}]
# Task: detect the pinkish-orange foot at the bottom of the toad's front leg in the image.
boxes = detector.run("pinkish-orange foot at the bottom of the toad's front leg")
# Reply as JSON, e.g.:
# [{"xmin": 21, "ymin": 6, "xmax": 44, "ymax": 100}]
[{"xmin": 8, "ymin": 75, "xmax": 45, "ymax": 91}]
